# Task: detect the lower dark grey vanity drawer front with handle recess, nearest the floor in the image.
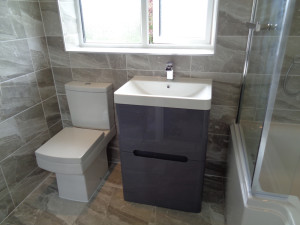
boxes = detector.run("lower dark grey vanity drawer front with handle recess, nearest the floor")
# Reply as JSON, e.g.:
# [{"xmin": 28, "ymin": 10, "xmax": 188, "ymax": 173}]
[{"xmin": 121, "ymin": 152, "xmax": 205, "ymax": 212}]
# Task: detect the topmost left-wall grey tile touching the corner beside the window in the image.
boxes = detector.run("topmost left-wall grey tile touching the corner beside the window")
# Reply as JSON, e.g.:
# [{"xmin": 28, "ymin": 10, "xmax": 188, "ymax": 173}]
[{"xmin": 19, "ymin": 1, "xmax": 45, "ymax": 37}]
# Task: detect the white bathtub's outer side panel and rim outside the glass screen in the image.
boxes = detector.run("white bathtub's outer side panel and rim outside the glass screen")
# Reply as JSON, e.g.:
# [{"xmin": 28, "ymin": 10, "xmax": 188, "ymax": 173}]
[{"xmin": 226, "ymin": 124, "xmax": 300, "ymax": 225}]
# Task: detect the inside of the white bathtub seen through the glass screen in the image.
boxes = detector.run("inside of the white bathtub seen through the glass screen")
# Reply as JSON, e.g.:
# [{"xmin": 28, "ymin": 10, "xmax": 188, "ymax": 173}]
[{"xmin": 259, "ymin": 123, "xmax": 300, "ymax": 198}]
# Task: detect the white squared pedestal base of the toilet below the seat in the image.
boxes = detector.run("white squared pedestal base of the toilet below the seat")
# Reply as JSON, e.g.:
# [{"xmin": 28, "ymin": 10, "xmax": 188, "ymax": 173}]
[{"xmin": 56, "ymin": 148, "xmax": 108, "ymax": 202}]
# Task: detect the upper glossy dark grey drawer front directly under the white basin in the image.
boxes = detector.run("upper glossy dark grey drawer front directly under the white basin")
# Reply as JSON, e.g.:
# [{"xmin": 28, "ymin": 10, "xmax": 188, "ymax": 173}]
[{"xmin": 116, "ymin": 104, "xmax": 209, "ymax": 160}]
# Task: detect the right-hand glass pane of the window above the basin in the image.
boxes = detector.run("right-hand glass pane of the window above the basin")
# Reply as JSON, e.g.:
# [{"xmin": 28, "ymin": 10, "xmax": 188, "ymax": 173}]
[{"xmin": 153, "ymin": 0, "xmax": 211, "ymax": 44}]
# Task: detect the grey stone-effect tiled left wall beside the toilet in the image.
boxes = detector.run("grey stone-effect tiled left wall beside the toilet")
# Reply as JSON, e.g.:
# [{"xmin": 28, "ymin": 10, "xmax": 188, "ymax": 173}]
[{"xmin": 0, "ymin": 0, "xmax": 61, "ymax": 220}]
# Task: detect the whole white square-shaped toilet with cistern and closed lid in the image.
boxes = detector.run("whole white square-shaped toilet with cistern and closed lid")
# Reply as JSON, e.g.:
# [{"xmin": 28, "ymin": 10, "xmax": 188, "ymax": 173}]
[{"xmin": 35, "ymin": 81, "xmax": 116, "ymax": 202}]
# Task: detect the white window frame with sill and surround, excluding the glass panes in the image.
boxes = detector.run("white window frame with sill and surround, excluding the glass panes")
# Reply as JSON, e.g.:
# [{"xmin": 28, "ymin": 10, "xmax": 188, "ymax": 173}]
[{"xmin": 59, "ymin": 0, "xmax": 219, "ymax": 55}]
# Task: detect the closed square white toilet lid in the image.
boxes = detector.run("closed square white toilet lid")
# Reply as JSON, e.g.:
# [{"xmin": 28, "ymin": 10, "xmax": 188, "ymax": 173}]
[{"xmin": 35, "ymin": 127, "xmax": 104, "ymax": 163}]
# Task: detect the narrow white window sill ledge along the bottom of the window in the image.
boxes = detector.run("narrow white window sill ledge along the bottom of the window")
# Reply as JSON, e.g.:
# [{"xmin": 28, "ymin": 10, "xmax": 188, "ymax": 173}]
[{"xmin": 66, "ymin": 46, "xmax": 214, "ymax": 55}]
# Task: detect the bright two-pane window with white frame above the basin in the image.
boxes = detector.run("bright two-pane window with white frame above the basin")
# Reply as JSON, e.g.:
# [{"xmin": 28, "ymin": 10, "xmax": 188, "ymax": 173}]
[{"xmin": 74, "ymin": 0, "xmax": 217, "ymax": 54}]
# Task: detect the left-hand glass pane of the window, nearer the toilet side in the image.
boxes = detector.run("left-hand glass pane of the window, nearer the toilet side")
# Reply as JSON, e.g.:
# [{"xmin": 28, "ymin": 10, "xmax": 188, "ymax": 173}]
[{"xmin": 81, "ymin": 0, "xmax": 142, "ymax": 44}]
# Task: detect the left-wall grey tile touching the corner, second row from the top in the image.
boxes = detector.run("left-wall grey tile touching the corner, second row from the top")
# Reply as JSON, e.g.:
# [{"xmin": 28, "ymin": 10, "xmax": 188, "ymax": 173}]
[{"xmin": 28, "ymin": 37, "xmax": 50, "ymax": 71}]
